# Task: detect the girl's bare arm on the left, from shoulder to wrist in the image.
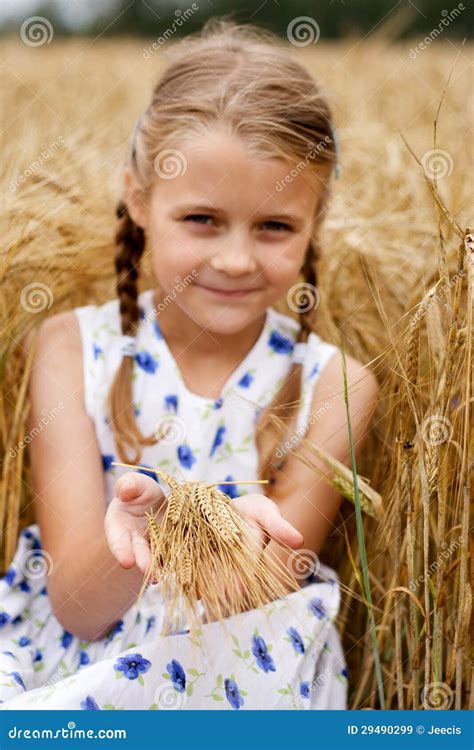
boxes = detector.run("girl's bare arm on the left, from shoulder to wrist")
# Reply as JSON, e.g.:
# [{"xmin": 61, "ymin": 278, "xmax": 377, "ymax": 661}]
[{"xmin": 27, "ymin": 311, "xmax": 150, "ymax": 640}]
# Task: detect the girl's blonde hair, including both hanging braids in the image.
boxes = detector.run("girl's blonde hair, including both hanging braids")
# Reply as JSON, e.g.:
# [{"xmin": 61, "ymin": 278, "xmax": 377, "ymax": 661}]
[{"xmin": 108, "ymin": 20, "xmax": 337, "ymax": 494}]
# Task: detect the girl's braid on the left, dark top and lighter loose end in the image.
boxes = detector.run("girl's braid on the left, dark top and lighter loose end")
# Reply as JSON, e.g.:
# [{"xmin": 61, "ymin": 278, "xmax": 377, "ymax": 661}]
[{"xmin": 108, "ymin": 201, "xmax": 157, "ymax": 464}]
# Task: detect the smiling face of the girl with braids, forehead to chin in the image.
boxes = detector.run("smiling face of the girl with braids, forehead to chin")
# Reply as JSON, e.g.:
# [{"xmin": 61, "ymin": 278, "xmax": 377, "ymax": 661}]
[{"xmin": 126, "ymin": 131, "xmax": 332, "ymax": 334}]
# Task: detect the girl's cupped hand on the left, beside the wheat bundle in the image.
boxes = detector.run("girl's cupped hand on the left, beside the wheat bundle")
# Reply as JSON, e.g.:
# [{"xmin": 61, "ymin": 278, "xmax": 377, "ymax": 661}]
[{"xmin": 104, "ymin": 471, "xmax": 166, "ymax": 574}]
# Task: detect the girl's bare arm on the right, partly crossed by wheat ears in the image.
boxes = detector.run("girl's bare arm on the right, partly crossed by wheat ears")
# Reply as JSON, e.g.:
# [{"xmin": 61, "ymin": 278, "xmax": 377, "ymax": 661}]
[{"xmin": 269, "ymin": 352, "xmax": 379, "ymax": 570}]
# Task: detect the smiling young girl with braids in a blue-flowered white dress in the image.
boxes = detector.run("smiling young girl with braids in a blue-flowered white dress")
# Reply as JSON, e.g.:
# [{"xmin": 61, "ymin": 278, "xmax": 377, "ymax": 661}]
[{"xmin": 0, "ymin": 17, "xmax": 377, "ymax": 710}]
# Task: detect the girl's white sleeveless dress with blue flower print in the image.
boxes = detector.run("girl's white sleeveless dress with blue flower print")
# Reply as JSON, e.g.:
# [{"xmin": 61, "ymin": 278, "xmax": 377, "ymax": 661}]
[{"xmin": 0, "ymin": 290, "xmax": 348, "ymax": 710}]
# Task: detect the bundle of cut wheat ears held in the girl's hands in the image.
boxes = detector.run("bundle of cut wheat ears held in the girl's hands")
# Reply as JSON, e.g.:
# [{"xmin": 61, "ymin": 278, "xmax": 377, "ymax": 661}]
[{"xmin": 114, "ymin": 462, "xmax": 299, "ymax": 635}]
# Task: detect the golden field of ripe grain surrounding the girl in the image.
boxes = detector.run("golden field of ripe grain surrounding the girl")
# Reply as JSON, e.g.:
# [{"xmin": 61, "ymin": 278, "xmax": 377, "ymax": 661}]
[{"xmin": 0, "ymin": 3, "xmax": 474, "ymax": 709}]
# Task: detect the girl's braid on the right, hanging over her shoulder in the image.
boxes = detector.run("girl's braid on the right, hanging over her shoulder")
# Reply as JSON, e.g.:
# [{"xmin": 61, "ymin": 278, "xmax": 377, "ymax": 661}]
[{"xmin": 256, "ymin": 240, "xmax": 320, "ymax": 492}]
